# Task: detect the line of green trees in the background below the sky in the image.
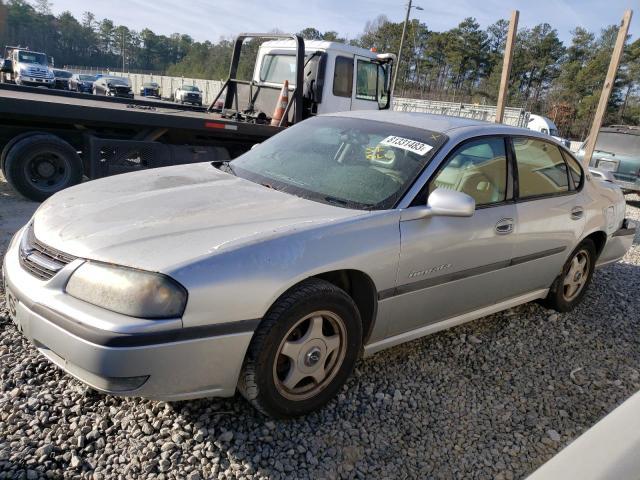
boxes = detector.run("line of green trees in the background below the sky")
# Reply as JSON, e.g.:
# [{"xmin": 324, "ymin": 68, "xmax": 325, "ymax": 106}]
[{"xmin": 0, "ymin": 0, "xmax": 640, "ymax": 138}]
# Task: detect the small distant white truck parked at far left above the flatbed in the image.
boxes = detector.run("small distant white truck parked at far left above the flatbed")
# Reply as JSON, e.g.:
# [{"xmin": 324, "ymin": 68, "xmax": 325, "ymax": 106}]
[{"xmin": 2, "ymin": 46, "xmax": 55, "ymax": 88}]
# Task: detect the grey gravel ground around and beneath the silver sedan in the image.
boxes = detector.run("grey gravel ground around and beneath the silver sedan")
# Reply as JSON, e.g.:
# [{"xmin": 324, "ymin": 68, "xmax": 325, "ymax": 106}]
[{"xmin": 0, "ymin": 174, "xmax": 640, "ymax": 480}]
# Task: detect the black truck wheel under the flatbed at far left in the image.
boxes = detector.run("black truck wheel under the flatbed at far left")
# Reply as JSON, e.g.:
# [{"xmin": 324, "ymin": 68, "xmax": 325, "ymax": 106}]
[{"xmin": 4, "ymin": 135, "xmax": 82, "ymax": 202}]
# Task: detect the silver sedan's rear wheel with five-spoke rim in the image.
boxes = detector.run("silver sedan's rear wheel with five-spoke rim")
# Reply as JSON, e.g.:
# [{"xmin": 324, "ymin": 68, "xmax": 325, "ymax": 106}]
[{"xmin": 542, "ymin": 239, "xmax": 597, "ymax": 312}]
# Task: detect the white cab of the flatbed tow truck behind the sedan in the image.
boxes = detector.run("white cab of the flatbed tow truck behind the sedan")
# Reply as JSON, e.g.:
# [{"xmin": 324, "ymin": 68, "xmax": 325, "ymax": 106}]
[{"xmin": 253, "ymin": 40, "xmax": 394, "ymax": 115}]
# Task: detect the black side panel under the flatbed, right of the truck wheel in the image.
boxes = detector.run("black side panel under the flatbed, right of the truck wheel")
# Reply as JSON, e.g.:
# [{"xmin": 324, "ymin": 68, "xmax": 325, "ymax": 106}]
[{"xmin": 87, "ymin": 136, "xmax": 230, "ymax": 179}]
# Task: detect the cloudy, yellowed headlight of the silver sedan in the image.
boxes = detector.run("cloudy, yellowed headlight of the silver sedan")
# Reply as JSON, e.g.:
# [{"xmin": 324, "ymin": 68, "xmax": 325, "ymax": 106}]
[{"xmin": 66, "ymin": 262, "xmax": 187, "ymax": 318}]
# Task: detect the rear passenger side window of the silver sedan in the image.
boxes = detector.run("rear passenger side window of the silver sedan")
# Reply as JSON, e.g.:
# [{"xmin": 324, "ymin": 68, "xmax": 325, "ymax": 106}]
[{"xmin": 513, "ymin": 137, "xmax": 569, "ymax": 198}]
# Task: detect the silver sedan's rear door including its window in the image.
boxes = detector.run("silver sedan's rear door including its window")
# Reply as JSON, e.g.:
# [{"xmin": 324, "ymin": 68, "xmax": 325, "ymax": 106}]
[{"xmin": 508, "ymin": 136, "xmax": 585, "ymax": 295}]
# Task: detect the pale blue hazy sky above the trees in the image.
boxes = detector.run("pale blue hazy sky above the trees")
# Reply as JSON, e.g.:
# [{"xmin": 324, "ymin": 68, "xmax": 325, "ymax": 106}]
[{"xmin": 51, "ymin": 0, "xmax": 640, "ymax": 43}]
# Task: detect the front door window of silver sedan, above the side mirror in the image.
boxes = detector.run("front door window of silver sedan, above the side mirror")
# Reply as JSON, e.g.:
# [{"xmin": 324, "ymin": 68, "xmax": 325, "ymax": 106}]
[{"xmin": 429, "ymin": 138, "xmax": 507, "ymax": 206}]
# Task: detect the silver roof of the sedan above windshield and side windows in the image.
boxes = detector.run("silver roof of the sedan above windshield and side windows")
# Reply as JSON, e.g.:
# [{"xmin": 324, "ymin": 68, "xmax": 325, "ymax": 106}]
[{"xmin": 328, "ymin": 110, "xmax": 549, "ymax": 139}]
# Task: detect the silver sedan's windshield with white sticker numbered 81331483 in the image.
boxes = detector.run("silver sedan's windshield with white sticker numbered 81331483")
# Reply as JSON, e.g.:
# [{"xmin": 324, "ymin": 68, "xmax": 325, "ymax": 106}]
[{"xmin": 230, "ymin": 117, "xmax": 447, "ymax": 210}]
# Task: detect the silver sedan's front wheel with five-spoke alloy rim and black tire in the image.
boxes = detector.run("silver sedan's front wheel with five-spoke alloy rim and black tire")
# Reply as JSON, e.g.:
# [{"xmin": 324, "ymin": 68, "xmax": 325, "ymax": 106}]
[{"xmin": 238, "ymin": 279, "xmax": 362, "ymax": 418}]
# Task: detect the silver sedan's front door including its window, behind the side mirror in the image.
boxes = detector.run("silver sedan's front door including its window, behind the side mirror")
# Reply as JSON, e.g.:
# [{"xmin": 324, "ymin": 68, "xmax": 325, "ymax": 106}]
[{"xmin": 387, "ymin": 136, "xmax": 515, "ymax": 335}]
